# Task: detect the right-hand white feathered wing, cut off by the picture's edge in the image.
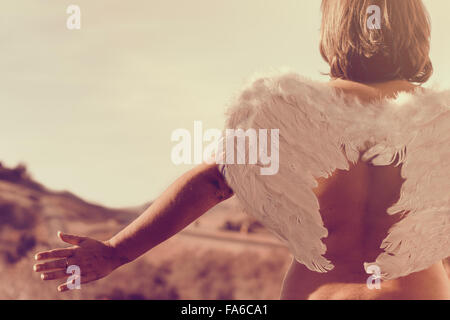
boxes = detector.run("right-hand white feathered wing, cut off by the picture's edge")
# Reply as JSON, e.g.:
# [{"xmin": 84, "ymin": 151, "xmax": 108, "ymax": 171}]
[{"xmin": 363, "ymin": 87, "xmax": 450, "ymax": 279}]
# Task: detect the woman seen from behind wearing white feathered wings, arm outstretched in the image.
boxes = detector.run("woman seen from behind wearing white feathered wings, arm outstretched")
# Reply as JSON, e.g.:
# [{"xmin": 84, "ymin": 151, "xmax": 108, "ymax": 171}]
[{"xmin": 34, "ymin": 0, "xmax": 450, "ymax": 299}]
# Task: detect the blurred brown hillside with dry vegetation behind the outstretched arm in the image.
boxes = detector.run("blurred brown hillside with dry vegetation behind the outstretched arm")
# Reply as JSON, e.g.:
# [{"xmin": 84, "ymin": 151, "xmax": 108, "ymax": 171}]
[{"xmin": 0, "ymin": 165, "xmax": 290, "ymax": 299}]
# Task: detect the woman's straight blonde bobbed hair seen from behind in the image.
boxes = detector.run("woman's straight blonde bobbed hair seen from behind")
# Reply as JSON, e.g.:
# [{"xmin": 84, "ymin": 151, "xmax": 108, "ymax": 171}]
[{"xmin": 320, "ymin": 0, "xmax": 433, "ymax": 83}]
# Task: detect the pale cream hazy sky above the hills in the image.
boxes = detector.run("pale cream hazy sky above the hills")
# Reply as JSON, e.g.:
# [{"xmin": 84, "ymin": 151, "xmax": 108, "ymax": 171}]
[{"xmin": 0, "ymin": 0, "xmax": 450, "ymax": 207}]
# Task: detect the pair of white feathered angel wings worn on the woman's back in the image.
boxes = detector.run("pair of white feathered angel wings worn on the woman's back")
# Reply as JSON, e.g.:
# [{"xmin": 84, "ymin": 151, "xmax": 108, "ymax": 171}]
[{"xmin": 224, "ymin": 73, "xmax": 450, "ymax": 278}]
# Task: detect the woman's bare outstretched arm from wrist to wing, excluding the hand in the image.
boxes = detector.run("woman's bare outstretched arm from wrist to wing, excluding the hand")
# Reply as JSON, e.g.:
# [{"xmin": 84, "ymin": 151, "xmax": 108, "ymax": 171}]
[{"xmin": 109, "ymin": 165, "xmax": 232, "ymax": 261}]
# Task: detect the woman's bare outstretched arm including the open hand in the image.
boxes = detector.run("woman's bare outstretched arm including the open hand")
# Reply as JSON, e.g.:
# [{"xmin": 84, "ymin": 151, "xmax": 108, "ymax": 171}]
[{"xmin": 34, "ymin": 164, "xmax": 233, "ymax": 291}]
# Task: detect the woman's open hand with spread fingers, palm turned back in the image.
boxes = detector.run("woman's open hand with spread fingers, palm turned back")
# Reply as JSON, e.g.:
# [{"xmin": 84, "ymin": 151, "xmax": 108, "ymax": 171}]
[{"xmin": 33, "ymin": 232, "xmax": 124, "ymax": 292}]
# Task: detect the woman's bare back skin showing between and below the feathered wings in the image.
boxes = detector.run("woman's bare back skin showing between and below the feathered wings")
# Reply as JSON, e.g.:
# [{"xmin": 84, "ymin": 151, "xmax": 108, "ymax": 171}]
[{"xmin": 281, "ymin": 80, "xmax": 450, "ymax": 299}]
